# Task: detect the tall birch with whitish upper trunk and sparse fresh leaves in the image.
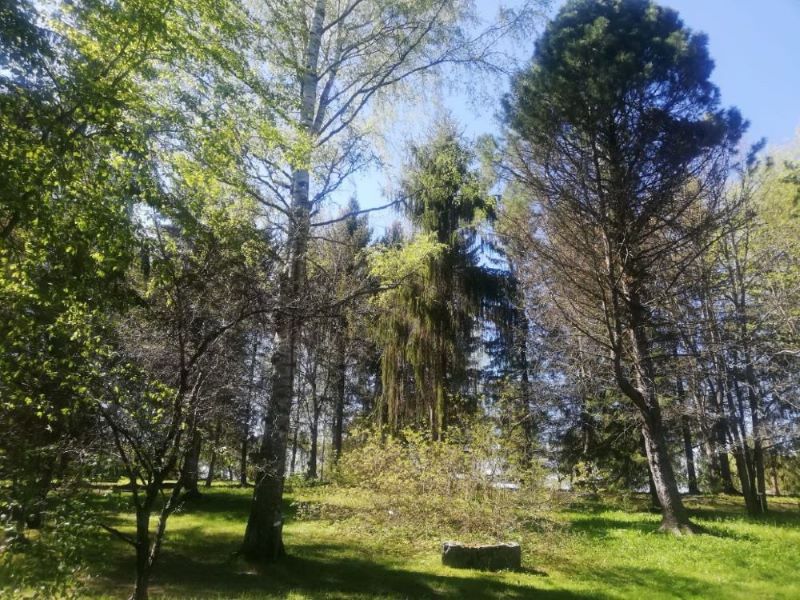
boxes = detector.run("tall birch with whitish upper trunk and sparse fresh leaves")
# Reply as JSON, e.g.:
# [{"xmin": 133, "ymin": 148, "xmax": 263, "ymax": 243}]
[{"xmin": 236, "ymin": 0, "xmax": 539, "ymax": 561}]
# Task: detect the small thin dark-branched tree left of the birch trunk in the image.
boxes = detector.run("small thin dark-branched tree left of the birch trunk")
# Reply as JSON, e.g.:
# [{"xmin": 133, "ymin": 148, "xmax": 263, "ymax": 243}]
[{"xmin": 98, "ymin": 198, "xmax": 263, "ymax": 600}]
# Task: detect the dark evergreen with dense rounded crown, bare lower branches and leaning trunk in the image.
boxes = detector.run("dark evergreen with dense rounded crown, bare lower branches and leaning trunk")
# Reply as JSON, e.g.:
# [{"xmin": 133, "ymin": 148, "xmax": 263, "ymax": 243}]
[{"xmin": 505, "ymin": 0, "xmax": 744, "ymax": 532}]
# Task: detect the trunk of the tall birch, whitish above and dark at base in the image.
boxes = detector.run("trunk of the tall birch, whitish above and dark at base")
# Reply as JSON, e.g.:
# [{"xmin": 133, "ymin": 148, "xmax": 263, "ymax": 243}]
[{"xmin": 242, "ymin": 0, "xmax": 326, "ymax": 562}]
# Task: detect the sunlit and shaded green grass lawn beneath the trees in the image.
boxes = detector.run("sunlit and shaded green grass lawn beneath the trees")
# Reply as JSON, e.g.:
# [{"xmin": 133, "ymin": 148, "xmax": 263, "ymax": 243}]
[{"xmin": 1, "ymin": 487, "xmax": 800, "ymax": 599}]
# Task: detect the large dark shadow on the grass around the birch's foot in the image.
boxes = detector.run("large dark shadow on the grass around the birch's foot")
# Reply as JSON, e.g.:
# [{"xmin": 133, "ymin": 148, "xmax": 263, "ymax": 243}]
[{"xmin": 93, "ymin": 528, "xmax": 597, "ymax": 600}]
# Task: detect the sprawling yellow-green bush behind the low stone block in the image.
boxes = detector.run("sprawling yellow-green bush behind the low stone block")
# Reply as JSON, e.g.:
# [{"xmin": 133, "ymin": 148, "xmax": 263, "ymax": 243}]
[{"xmin": 336, "ymin": 424, "xmax": 549, "ymax": 542}]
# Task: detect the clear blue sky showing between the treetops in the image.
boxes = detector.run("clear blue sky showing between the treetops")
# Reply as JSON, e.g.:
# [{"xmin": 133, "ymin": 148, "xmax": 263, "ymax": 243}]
[{"xmin": 343, "ymin": 0, "xmax": 800, "ymax": 233}]
